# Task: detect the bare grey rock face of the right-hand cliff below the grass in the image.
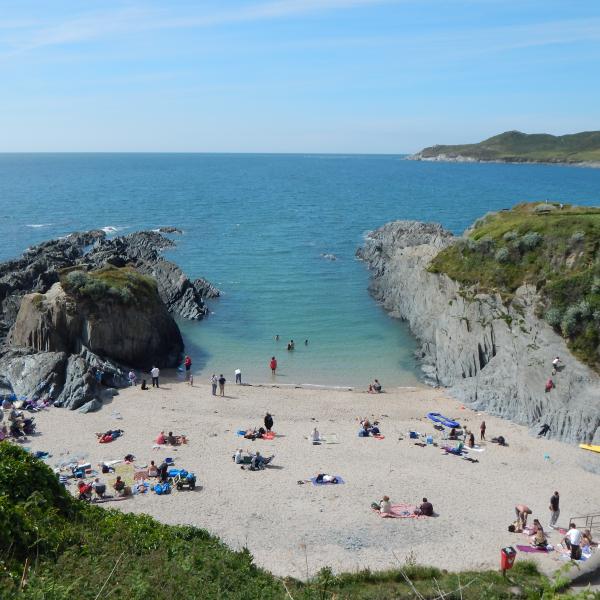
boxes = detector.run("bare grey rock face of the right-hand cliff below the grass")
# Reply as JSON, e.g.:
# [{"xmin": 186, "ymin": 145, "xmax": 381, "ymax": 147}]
[{"xmin": 357, "ymin": 221, "xmax": 600, "ymax": 443}]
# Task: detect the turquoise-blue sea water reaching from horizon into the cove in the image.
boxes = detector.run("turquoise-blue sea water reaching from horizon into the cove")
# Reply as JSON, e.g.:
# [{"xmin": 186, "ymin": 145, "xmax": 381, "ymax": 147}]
[{"xmin": 0, "ymin": 154, "xmax": 600, "ymax": 386}]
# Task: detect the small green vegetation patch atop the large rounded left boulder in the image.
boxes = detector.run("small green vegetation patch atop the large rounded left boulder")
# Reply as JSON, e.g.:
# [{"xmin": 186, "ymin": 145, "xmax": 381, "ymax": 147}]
[{"xmin": 60, "ymin": 265, "xmax": 159, "ymax": 305}]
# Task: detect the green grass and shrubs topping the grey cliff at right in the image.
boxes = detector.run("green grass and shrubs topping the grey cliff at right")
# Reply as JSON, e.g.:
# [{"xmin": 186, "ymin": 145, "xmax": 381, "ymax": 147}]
[{"xmin": 430, "ymin": 203, "xmax": 600, "ymax": 370}]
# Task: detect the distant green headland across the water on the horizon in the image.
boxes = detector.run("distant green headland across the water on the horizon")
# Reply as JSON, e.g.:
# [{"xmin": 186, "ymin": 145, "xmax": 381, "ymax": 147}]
[{"xmin": 417, "ymin": 131, "xmax": 600, "ymax": 164}]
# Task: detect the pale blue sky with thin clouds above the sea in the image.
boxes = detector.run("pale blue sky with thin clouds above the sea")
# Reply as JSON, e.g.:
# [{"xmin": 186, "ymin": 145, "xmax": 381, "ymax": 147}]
[{"xmin": 0, "ymin": 0, "xmax": 600, "ymax": 154}]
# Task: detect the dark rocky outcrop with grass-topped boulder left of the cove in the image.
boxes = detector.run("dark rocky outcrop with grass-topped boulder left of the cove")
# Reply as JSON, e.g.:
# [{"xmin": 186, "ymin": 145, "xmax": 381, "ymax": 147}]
[{"xmin": 0, "ymin": 231, "xmax": 219, "ymax": 410}]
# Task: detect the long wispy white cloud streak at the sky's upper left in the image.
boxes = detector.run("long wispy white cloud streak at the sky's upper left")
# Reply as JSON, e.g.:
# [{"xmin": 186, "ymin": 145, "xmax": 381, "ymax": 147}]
[{"xmin": 0, "ymin": 0, "xmax": 402, "ymax": 57}]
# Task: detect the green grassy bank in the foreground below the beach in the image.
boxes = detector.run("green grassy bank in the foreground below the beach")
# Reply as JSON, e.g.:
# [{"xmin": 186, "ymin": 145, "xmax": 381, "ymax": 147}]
[{"xmin": 0, "ymin": 442, "xmax": 600, "ymax": 600}]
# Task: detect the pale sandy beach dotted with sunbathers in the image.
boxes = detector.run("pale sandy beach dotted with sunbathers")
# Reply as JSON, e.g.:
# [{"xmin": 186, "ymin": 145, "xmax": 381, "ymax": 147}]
[{"xmin": 26, "ymin": 379, "xmax": 600, "ymax": 578}]
